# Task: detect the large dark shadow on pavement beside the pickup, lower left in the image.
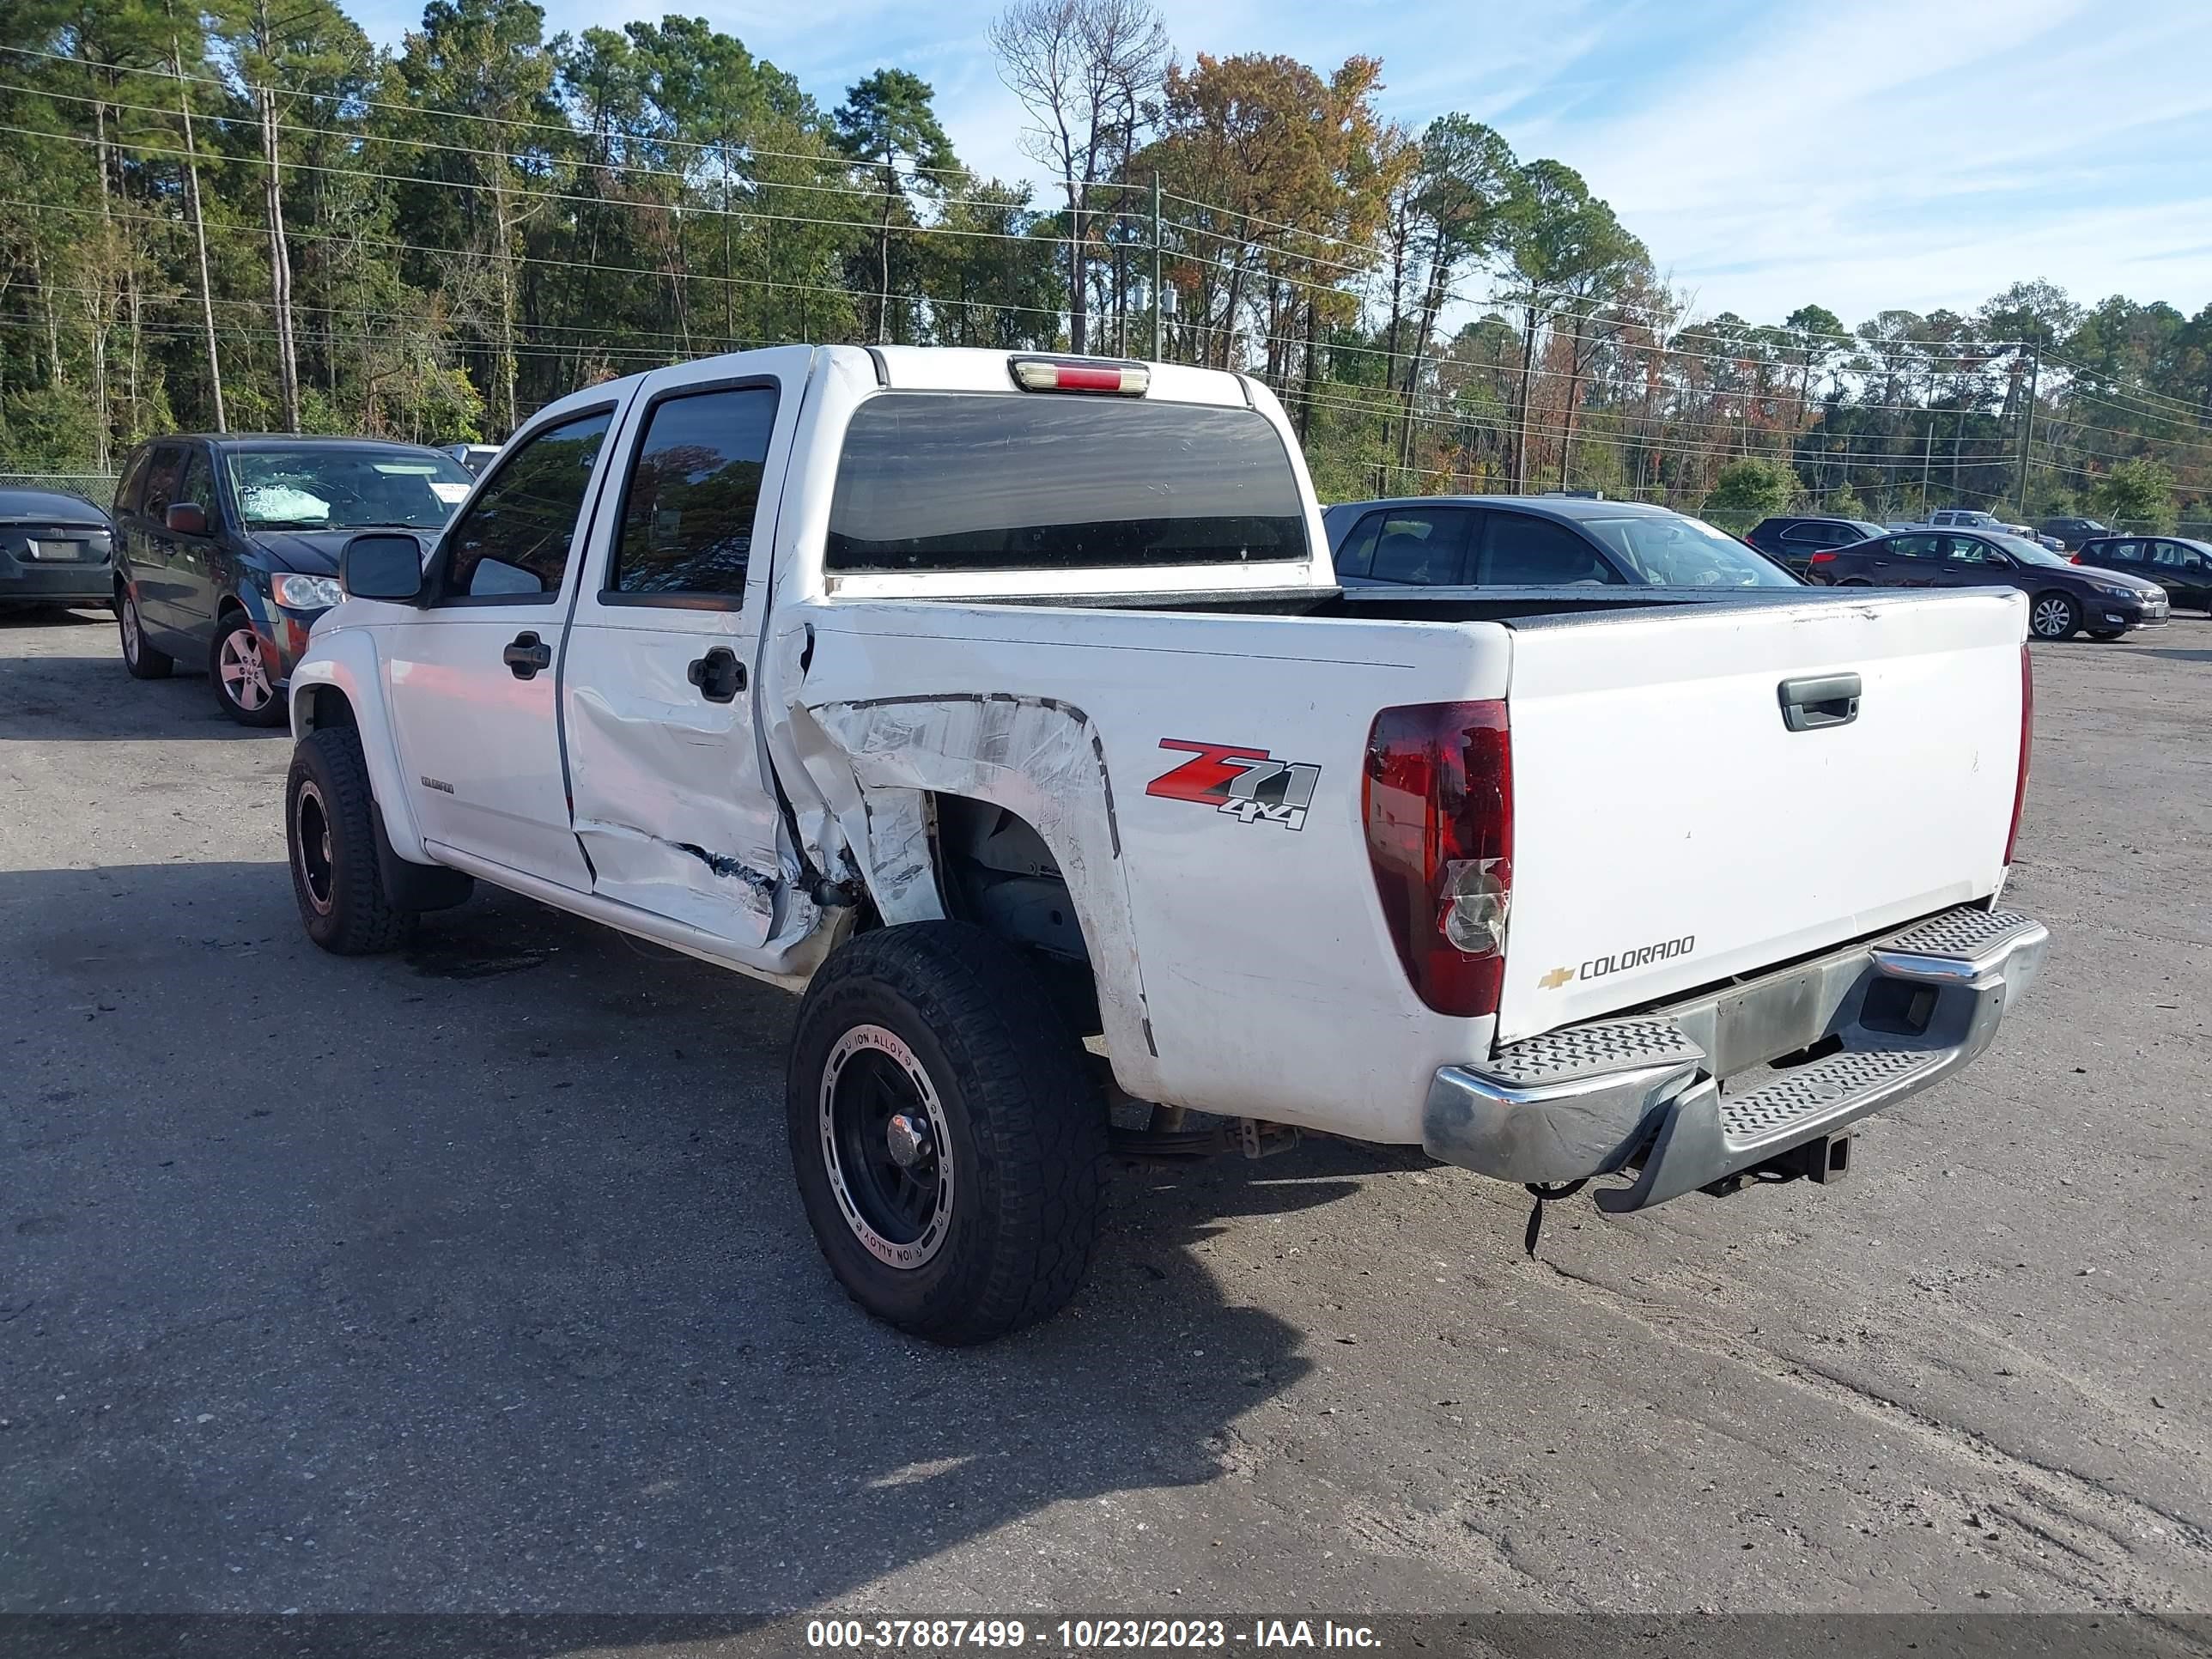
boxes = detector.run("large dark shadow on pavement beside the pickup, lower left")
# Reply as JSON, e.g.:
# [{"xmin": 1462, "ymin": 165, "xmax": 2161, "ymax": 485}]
[{"xmin": 0, "ymin": 863, "xmax": 1327, "ymax": 1624}]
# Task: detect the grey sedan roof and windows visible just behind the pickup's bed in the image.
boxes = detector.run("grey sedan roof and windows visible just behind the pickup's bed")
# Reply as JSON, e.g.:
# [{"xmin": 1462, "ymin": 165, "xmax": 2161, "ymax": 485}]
[{"xmin": 1322, "ymin": 495, "xmax": 1794, "ymax": 588}]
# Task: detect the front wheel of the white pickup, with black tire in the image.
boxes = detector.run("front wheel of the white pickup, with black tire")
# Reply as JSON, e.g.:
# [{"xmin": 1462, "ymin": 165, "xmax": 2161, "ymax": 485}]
[{"xmin": 283, "ymin": 726, "xmax": 414, "ymax": 956}]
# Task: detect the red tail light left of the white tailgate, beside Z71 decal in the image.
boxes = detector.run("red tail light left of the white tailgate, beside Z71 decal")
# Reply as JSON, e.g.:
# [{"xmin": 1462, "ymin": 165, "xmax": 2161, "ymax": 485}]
[{"xmin": 1360, "ymin": 703, "xmax": 1513, "ymax": 1015}]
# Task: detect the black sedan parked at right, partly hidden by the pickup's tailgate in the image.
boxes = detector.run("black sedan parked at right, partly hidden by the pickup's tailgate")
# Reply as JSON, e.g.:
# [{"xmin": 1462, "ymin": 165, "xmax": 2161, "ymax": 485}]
[{"xmin": 1809, "ymin": 531, "xmax": 2170, "ymax": 639}]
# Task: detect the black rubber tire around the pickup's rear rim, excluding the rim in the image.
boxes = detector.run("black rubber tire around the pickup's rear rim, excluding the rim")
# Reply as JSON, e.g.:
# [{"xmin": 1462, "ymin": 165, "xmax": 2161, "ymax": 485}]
[{"xmin": 785, "ymin": 922, "xmax": 1106, "ymax": 1343}]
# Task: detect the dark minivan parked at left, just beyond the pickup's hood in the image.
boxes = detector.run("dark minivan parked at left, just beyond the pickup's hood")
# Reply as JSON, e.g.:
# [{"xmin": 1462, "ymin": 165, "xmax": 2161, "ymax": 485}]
[{"xmin": 111, "ymin": 434, "xmax": 473, "ymax": 726}]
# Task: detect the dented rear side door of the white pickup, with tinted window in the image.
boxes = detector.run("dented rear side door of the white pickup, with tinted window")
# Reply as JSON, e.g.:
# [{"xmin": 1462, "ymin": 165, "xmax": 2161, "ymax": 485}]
[{"xmin": 562, "ymin": 349, "xmax": 811, "ymax": 949}]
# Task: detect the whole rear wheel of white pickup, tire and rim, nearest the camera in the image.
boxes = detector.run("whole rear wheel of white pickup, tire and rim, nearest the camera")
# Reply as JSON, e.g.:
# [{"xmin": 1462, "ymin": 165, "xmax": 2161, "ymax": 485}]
[{"xmin": 785, "ymin": 922, "xmax": 1106, "ymax": 1343}]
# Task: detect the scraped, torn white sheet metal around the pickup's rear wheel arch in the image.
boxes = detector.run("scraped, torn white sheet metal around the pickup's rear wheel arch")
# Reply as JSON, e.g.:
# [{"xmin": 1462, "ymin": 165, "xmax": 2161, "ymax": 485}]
[{"xmin": 790, "ymin": 695, "xmax": 1157, "ymax": 1099}]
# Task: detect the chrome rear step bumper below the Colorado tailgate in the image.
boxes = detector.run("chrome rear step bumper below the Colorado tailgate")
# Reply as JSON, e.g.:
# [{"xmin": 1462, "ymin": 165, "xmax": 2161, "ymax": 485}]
[{"xmin": 1422, "ymin": 909, "xmax": 2051, "ymax": 1212}]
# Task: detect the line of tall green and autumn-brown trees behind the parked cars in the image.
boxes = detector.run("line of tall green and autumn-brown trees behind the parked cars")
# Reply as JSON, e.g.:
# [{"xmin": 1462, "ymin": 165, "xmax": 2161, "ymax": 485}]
[{"xmin": 0, "ymin": 0, "xmax": 2212, "ymax": 522}]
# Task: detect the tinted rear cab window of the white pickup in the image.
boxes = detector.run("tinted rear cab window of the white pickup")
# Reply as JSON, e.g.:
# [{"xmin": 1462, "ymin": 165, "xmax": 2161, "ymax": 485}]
[{"xmin": 823, "ymin": 392, "xmax": 1312, "ymax": 573}]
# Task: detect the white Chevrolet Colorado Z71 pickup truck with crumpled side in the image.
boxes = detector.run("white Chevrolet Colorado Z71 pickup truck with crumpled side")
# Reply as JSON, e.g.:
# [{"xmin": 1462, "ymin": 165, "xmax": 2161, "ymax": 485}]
[{"xmin": 285, "ymin": 347, "xmax": 2046, "ymax": 1340}]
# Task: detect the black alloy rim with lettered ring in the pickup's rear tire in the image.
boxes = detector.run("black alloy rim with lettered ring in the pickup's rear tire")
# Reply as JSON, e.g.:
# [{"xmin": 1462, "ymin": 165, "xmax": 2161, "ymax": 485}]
[{"xmin": 821, "ymin": 1024, "xmax": 956, "ymax": 1272}]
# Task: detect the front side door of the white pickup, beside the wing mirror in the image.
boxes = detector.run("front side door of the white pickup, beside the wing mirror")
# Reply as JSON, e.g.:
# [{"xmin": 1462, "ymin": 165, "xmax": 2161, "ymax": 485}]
[{"xmin": 385, "ymin": 400, "xmax": 622, "ymax": 891}]
